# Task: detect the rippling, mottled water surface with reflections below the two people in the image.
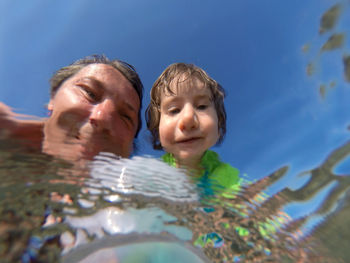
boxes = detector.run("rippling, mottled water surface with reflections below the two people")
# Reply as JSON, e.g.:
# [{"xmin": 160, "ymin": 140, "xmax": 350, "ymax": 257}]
[{"xmin": 0, "ymin": 139, "xmax": 350, "ymax": 262}]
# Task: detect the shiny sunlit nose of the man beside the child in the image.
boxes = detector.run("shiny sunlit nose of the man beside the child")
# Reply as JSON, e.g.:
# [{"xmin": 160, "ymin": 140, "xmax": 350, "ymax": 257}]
[{"xmin": 89, "ymin": 99, "xmax": 115, "ymax": 132}]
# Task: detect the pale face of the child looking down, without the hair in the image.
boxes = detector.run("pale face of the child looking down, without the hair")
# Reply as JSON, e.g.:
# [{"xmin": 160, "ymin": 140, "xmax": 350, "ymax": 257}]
[{"xmin": 159, "ymin": 77, "xmax": 219, "ymax": 165}]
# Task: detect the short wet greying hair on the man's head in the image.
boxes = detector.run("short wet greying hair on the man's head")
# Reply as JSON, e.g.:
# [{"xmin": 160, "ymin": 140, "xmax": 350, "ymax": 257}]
[{"xmin": 50, "ymin": 55, "xmax": 143, "ymax": 138}]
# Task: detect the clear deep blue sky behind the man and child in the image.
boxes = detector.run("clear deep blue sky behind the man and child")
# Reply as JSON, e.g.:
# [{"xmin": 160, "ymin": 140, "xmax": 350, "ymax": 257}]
[{"xmin": 0, "ymin": 0, "xmax": 350, "ymax": 183}]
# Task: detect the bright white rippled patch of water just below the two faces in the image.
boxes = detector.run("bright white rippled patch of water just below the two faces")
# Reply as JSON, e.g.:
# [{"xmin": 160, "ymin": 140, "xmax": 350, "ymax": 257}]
[{"xmin": 86, "ymin": 154, "xmax": 198, "ymax": 202}]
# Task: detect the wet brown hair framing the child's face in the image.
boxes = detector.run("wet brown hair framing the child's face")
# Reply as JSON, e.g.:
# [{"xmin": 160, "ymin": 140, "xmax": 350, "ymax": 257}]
[{"xmin": 145, "ymin": 63, "xmax": 226, "ymax": 150}]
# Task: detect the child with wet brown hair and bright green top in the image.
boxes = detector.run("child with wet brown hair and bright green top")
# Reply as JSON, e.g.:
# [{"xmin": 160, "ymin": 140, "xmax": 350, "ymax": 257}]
[{"xmin": 146, "ymin": 63, "xmax": 239, "ymax": 196}]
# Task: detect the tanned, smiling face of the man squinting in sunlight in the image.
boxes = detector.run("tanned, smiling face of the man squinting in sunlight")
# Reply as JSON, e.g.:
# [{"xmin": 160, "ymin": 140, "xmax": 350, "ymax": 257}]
[{"xmin": 43, "ymin": 64, "xmax": 140, "ymax": 160}]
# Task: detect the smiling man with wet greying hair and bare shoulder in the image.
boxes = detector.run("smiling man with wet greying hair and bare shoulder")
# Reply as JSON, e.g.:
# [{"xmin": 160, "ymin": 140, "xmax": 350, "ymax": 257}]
[{"xmin": 0, "ymin": 56, "xmax": 143, "ymax": 161}]
